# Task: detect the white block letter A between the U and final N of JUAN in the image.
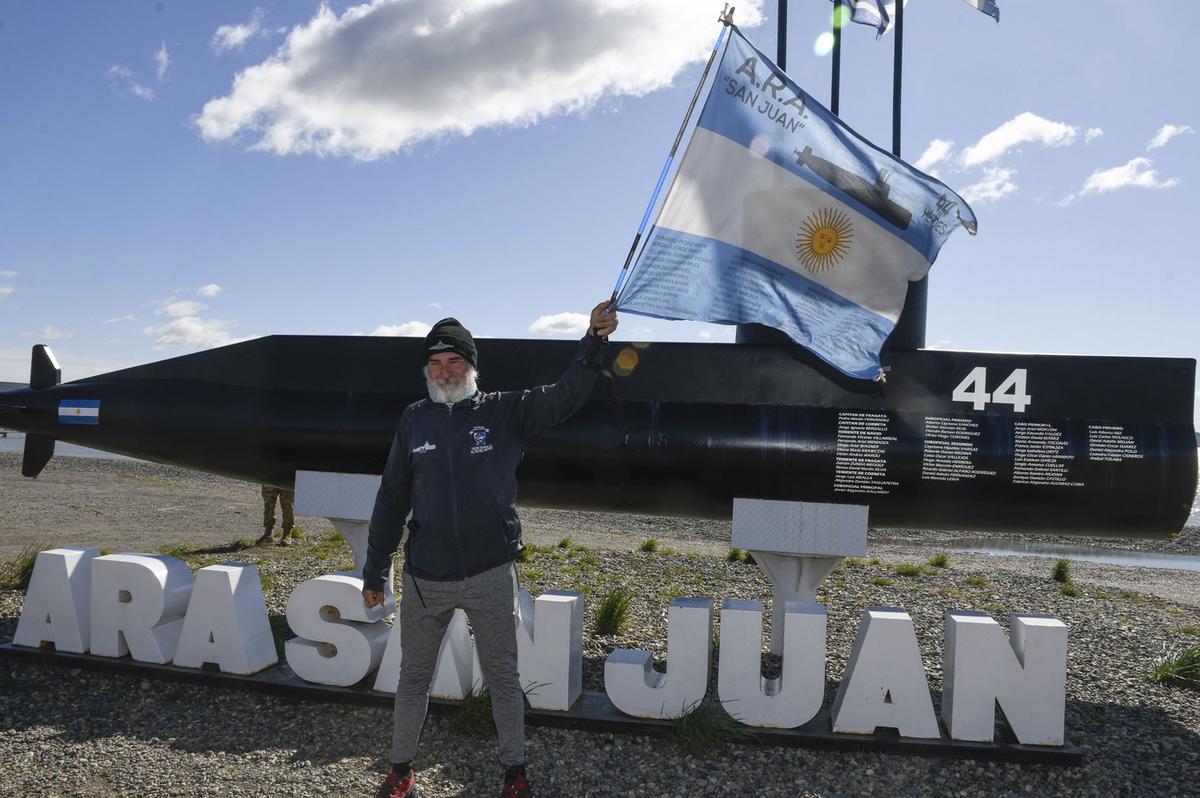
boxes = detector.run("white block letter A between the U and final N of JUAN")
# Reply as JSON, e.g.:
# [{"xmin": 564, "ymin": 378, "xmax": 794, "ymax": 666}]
[{"xmin": 832, "ymin": 607, "xmax": 941, "ymax": 738}]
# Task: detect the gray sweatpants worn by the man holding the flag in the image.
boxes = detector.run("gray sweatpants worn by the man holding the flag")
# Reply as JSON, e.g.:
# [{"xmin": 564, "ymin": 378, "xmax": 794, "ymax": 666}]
[{"xmin": 391, "ymin": 563, "xmax": 524, "ymax": 767}]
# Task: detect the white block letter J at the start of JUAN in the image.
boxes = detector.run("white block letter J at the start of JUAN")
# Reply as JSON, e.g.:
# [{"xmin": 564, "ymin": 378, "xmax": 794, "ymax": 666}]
[{"xmin": 604, "ymin": 599, "xmax": 713, "ymax": 719}]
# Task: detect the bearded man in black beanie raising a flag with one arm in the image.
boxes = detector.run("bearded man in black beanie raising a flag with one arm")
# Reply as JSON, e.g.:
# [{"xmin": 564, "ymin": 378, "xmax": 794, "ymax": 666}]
[{"xmin": 362, "ymin": 301, "xmax": 617, "ymax": 798}]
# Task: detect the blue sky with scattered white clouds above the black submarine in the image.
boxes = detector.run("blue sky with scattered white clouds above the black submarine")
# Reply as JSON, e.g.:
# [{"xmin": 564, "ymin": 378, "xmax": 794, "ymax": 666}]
[{"xmin": 0, "ymin": 0, "xmax": 1200, "ymax": 429}]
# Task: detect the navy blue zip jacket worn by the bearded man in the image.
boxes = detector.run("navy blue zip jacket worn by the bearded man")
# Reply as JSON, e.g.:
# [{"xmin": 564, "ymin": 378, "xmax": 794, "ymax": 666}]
[{"xmin": 362, "ymin": 336, "xmax": 604, "ymax": 590}]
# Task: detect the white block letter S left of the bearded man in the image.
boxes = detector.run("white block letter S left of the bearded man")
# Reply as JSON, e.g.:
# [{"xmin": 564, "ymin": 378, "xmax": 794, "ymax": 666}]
[{"xmin": 283, "ymin": 574, "xmax": 390, "ymax": 686}]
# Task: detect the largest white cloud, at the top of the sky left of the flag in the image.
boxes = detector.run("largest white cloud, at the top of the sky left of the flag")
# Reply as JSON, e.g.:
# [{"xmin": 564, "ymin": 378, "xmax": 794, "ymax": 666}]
[{"xmin": 194, "ymin": 0, "xmax": 762, "ymax": 160}]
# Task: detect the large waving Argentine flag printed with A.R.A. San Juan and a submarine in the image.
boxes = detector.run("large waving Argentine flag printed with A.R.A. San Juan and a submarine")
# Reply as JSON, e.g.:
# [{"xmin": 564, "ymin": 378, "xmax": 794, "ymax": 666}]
[{"xmin": 617, "ymin": 28, "xmax": 976, "ymax": 379}]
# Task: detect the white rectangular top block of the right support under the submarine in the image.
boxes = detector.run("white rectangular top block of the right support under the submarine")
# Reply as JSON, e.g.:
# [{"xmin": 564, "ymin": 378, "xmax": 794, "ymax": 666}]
[{"xmin": 733, "ymin": 498, "xmax": 868, "ymax": 557}]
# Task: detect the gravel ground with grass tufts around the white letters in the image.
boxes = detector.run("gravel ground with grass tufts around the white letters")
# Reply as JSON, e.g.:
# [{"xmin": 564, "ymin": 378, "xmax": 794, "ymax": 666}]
[{"xmin": 0, "ymin": 456, "xmax": 1200, "ymax": 797}]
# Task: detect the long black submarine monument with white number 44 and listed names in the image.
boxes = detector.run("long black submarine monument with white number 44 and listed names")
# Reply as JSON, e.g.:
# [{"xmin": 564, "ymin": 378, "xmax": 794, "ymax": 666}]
[{"xmin": 0, "ymin": 328, "xmax": 1196, "ymax": 536}]
